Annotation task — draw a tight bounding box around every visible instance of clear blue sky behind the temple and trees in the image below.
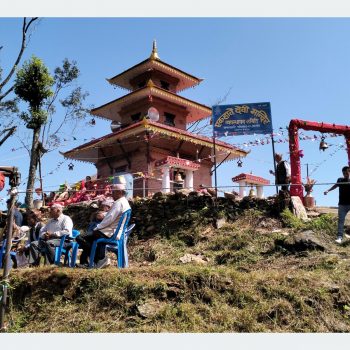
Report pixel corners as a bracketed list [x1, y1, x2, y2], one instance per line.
[0, 18, 350, 205]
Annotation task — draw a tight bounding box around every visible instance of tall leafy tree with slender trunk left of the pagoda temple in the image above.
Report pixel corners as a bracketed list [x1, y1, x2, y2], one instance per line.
[14, 57, 88, 207]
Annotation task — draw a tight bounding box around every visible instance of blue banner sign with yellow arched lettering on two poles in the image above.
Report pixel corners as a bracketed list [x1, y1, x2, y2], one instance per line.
[212, 102, 272, 137]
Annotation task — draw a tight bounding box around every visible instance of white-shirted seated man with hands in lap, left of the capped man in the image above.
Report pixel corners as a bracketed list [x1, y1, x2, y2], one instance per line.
[29, 203, 73, 266]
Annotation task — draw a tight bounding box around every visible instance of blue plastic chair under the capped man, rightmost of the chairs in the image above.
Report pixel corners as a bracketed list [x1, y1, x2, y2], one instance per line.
[89, 209, 131, 268]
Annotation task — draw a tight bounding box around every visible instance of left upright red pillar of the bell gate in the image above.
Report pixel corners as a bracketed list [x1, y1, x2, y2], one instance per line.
[289, 120, 303, 200]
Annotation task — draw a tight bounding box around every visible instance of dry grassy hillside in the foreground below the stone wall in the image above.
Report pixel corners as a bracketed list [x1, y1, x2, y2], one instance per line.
[4, 209, 350, 332]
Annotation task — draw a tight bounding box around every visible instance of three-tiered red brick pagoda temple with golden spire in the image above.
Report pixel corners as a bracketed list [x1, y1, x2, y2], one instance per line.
[62, 41, 247, 196]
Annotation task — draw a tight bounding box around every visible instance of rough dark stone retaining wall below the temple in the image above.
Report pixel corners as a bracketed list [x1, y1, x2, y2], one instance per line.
[65, 191, 281, 238]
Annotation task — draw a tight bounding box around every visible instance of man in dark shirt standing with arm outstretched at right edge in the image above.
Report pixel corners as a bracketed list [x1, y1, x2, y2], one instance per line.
[324, 166, 350, 244]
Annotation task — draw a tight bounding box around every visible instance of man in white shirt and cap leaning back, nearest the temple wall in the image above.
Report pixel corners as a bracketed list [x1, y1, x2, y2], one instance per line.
[76, 184, 130, 268]
